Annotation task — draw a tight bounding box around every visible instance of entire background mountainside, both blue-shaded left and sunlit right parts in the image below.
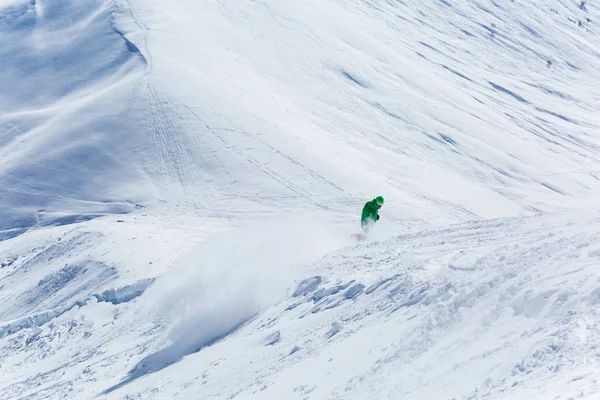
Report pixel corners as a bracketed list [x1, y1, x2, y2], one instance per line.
[0, 0, 600, 237]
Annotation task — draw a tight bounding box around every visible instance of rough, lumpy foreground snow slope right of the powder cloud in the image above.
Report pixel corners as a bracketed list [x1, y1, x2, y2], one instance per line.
[105, 211, 600, 399]
